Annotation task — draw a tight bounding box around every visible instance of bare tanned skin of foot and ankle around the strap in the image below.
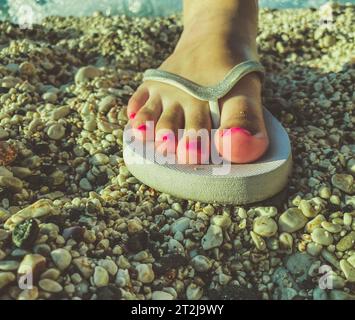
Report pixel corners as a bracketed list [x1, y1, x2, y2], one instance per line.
[127, 0, 269, 164]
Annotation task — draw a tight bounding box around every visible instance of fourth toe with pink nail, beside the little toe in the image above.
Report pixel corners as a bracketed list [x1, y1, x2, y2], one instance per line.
[131, 96, 162, 141]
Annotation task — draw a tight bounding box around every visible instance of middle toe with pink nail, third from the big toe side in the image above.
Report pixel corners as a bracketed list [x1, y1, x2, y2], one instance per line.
[155, 104, 184, 155]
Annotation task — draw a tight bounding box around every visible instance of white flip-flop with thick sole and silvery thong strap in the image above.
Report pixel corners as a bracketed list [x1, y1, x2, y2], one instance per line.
[123, 60, 292, 205]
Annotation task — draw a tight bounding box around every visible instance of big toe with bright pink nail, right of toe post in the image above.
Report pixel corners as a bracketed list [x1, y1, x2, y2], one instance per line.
[215, 95, 269, 163]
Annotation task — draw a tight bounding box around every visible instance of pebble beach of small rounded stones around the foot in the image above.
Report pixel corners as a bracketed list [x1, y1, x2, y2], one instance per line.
[0, 6, 355, 300]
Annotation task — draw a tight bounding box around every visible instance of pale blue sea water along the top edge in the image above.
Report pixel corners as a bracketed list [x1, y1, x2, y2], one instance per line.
[0, 0, 355, 22]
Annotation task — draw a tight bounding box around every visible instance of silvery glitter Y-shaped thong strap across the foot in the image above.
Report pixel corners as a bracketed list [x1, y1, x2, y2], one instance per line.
[143, 60, 265, 129]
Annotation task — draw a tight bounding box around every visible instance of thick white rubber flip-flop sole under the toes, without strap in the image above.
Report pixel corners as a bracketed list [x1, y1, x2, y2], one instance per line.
[123, 108, 292, 205]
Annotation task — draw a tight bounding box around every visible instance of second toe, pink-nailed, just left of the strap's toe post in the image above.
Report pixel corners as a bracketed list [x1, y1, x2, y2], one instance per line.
[177, 103, 211, 164]
